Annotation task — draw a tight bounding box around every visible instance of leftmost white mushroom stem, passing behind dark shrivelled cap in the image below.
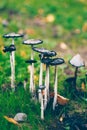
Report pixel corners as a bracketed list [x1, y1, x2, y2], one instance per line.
[10, 39, 15, 91]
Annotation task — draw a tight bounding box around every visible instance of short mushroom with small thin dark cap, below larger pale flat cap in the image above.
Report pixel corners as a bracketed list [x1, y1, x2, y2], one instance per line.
[25, 60, 37, 93]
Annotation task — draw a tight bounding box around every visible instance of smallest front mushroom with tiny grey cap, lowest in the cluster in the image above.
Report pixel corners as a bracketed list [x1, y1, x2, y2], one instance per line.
[38, 85, 45, 120]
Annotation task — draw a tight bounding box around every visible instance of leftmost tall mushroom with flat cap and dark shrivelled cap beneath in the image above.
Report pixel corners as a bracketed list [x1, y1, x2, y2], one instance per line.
[3, 32, 23, 91]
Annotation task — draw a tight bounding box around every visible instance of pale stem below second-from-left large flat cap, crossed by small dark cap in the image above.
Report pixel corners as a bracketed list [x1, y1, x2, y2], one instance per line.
[30, 50, 35, 93]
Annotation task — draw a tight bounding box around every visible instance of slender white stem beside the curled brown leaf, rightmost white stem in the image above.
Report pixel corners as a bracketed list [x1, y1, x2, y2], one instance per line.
[53, 65, 58, 110]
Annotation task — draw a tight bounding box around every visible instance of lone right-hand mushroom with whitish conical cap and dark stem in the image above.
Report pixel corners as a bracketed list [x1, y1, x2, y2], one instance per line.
[69, 54, 85, 90]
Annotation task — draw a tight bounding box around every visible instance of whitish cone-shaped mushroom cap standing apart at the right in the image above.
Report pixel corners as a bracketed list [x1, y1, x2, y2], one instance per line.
[70, 54, 85, 67]
